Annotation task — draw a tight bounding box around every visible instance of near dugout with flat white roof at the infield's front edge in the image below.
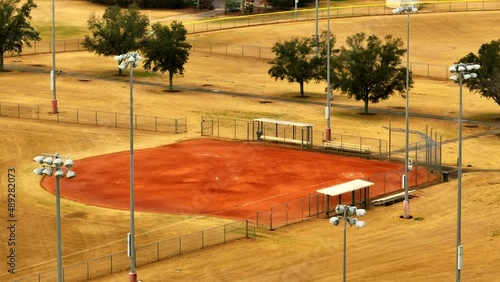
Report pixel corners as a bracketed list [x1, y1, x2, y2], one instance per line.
[316, 179, 375, 217]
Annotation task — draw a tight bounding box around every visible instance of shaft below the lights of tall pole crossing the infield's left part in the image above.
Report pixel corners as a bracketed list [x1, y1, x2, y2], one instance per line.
[128, 59, 137, 282]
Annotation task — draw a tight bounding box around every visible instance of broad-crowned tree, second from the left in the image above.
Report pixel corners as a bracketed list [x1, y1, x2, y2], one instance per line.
[82, 4, 149, 74]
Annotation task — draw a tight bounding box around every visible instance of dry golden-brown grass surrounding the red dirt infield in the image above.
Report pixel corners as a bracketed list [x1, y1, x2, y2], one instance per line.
[0, 1, 500, 282]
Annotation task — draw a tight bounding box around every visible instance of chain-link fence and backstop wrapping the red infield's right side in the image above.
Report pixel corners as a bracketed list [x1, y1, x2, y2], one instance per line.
[201, 117, 441, 230]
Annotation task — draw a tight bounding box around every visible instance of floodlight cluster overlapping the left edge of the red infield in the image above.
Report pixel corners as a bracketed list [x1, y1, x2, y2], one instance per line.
[33, 153, 76, 179]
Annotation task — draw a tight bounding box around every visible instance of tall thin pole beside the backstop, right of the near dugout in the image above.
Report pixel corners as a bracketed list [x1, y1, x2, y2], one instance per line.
[403, 9, 411, 219]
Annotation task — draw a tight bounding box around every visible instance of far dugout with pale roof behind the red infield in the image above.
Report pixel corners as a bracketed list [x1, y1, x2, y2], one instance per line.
[253, 118, 313, 147]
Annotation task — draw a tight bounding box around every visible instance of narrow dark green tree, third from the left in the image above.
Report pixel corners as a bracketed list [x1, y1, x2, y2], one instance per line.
[142, 21, 191, 91]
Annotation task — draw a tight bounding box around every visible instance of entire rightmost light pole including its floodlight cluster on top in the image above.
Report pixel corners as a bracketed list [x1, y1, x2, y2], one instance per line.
[449, 63, 481, 282]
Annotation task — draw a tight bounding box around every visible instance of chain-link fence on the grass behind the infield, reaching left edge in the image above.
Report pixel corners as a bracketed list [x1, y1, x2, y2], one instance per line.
[0, 102, 187, 134]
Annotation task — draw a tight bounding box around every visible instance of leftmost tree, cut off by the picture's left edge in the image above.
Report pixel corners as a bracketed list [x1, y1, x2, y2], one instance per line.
[0, 0, 41, 71]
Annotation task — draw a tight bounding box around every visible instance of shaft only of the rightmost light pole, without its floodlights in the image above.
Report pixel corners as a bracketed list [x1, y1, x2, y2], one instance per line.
[456, 72, 463, 282]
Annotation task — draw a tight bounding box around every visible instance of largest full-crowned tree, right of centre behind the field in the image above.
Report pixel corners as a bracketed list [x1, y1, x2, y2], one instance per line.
[331, 33, 413, 114]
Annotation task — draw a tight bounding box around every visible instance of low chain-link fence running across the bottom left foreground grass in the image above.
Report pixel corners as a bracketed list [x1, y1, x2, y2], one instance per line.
[14, 220, 256, 282]
